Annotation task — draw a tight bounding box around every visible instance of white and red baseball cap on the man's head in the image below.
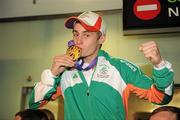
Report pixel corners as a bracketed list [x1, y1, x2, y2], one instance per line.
[65, 11, 106, 35]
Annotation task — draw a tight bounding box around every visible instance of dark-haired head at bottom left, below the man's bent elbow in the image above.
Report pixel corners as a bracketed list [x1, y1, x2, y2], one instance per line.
[14, 109, 48, 120]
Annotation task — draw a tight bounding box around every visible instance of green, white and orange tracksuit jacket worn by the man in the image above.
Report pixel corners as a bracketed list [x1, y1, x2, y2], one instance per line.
[29, 50, 174, 120]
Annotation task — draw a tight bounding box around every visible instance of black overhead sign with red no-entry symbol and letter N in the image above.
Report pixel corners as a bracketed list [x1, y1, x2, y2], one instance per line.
[123, 0, 180, 35]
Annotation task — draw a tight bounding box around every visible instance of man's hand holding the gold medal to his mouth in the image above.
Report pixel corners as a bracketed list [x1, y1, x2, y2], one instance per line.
[51, 54, 74, 76]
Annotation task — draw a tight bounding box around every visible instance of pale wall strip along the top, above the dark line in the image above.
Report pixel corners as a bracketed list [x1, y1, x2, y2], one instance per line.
[0, 0, 122, 18]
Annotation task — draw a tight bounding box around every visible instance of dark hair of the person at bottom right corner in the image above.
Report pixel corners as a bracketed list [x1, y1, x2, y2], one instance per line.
[150, 106, 180, 120]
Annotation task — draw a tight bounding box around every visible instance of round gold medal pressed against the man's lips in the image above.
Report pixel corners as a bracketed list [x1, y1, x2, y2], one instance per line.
[66, 45, 81, 61]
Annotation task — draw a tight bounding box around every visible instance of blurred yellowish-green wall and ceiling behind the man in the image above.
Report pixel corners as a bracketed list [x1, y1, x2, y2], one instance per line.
[0, 0, 180, 120]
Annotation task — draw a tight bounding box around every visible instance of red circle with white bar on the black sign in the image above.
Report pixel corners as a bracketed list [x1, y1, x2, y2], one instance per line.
[133, 0, 161, 20]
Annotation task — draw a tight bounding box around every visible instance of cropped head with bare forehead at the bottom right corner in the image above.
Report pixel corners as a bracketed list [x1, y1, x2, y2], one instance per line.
[149, 106, 180, 120]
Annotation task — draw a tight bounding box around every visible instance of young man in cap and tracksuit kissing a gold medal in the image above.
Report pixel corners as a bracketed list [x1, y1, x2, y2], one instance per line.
[30, 12, 173, 120]
